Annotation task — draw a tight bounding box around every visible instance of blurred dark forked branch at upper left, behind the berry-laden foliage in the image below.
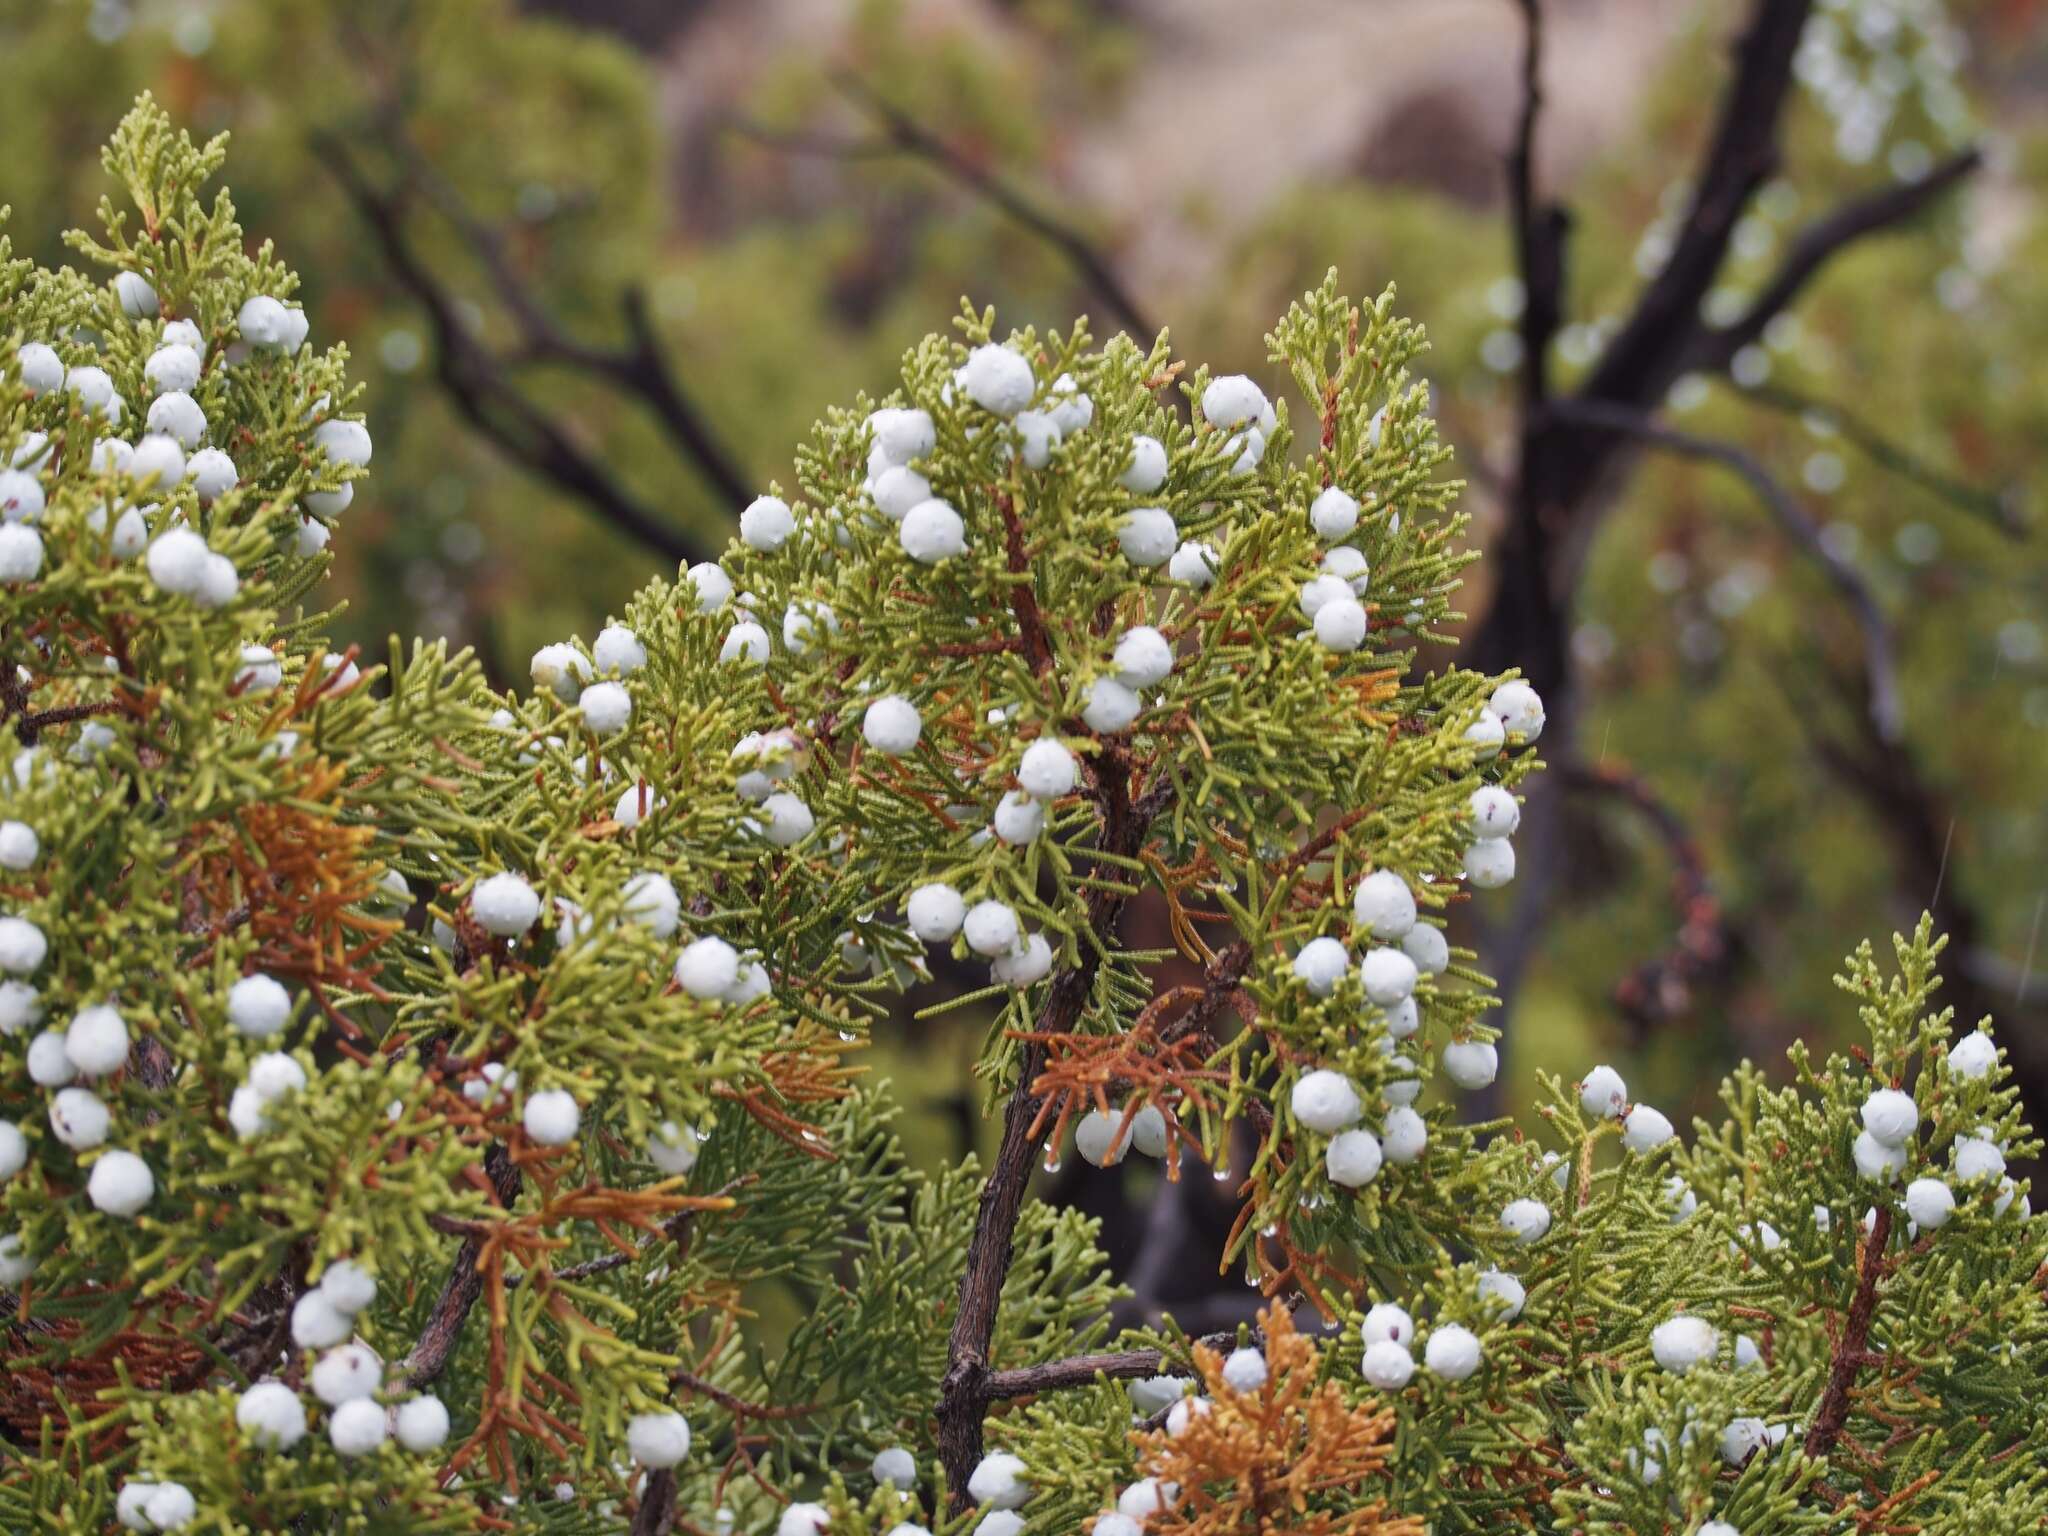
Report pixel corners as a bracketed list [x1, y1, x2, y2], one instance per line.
[319, 135, 748, 561]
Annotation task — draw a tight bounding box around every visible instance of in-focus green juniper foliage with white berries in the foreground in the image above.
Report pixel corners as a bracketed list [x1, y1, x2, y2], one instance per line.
[0, 102, 2048, 1536]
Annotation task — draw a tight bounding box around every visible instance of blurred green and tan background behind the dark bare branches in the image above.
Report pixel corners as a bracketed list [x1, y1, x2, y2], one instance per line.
[0, 0, 2048, 1204]
